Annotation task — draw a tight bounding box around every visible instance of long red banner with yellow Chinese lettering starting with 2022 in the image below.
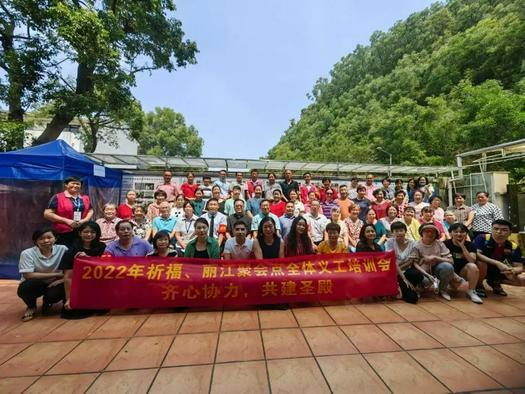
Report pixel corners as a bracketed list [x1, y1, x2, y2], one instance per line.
[71, 252, 397, 309]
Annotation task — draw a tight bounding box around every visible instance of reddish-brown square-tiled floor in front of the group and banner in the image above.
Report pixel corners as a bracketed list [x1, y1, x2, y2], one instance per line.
[0, 281, 525, 394]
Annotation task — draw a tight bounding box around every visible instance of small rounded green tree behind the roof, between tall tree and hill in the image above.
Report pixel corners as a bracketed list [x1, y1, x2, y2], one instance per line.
[131, 107, 203, 157]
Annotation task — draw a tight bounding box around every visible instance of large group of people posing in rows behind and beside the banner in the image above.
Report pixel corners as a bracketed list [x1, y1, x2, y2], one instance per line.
[18, 169, 525, 320]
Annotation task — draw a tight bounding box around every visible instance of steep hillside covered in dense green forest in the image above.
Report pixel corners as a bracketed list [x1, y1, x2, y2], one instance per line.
[268, 0, 525, 165]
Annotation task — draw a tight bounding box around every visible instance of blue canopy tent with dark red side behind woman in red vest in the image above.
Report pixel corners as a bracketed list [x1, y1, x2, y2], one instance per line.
[0, 140, 122, 278]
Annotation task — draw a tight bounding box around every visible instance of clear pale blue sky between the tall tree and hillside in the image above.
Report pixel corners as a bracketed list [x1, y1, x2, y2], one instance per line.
[134, 0, 434, 159]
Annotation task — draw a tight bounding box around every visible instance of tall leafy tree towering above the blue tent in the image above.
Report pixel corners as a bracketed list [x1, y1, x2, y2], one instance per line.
[0, 0, 197, 143]
